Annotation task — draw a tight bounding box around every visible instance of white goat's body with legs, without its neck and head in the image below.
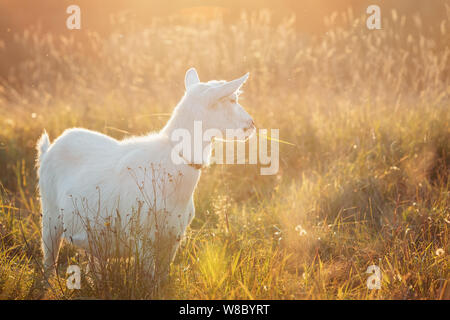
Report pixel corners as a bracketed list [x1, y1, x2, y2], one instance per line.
[39, 129, 200, 268]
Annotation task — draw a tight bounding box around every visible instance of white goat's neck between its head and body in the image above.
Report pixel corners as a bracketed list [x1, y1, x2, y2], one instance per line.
[161, 106, 212, 165]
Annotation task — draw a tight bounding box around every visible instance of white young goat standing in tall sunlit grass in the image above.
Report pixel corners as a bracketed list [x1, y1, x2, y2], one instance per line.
[37, 68, 255, 273]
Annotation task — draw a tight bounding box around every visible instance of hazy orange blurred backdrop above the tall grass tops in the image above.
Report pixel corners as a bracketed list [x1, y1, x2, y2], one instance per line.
[0, 0, 448, 35]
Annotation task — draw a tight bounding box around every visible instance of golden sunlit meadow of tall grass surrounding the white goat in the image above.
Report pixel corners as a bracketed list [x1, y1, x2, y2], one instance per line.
[0, 7, 450, 299]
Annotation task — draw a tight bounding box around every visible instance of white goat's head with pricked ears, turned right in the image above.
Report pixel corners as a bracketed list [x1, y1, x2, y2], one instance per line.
[183, 68, 255, 139]
